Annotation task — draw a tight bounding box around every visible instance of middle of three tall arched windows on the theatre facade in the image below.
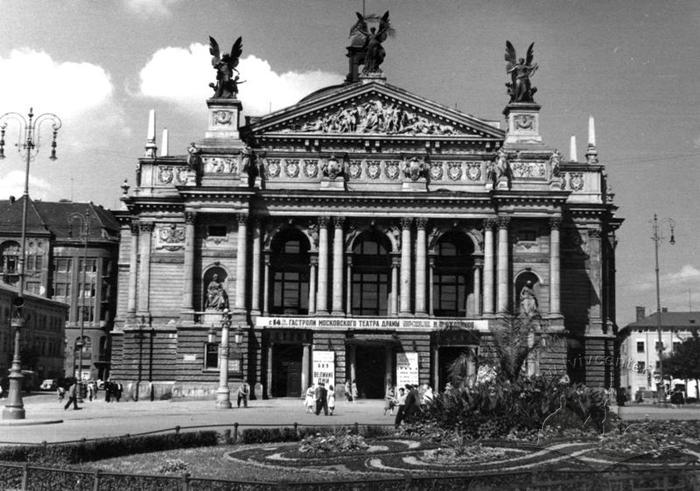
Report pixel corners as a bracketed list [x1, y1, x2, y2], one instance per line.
[351, 231, 391, 316]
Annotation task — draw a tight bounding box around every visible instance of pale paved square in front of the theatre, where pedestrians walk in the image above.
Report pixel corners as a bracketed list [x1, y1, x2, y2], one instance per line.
[0, 394, 700, 444]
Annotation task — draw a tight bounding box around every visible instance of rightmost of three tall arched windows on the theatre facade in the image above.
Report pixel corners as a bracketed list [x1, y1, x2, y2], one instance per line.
[433, 232, 474, 317]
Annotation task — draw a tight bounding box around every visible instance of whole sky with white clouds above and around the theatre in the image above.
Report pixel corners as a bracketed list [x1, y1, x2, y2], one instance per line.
[0, 0, 700, 326]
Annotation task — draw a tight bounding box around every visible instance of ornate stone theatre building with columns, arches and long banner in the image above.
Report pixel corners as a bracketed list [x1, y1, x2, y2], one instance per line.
[112, 21, 621, 397]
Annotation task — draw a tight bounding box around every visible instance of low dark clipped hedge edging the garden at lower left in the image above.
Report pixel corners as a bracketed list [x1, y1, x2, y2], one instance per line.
[0, 431, 218, 465]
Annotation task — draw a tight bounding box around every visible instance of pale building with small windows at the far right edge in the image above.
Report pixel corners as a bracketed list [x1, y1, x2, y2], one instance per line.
[619, 307, 700, 399]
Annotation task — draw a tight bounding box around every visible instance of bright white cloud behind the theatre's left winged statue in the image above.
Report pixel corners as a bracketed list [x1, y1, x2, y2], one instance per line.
[139, 43, 343, 115]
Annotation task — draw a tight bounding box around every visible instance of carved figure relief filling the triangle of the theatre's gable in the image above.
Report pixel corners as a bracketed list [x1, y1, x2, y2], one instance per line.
[300, 100, 458, 135]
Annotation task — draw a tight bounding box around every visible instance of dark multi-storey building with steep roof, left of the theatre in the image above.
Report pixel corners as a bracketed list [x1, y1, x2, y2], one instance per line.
[0, 199, 119, 379]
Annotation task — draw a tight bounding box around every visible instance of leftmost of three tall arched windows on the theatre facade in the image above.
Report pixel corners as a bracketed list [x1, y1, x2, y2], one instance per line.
[270, 229, 309, 315]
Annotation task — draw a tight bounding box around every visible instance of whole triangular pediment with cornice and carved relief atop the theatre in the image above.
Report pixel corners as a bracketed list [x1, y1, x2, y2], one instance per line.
[248, 82, 504, 140]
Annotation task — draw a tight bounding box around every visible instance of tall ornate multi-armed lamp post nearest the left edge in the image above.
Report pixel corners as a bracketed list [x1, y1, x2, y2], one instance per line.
[0, 108, 61, 419]
